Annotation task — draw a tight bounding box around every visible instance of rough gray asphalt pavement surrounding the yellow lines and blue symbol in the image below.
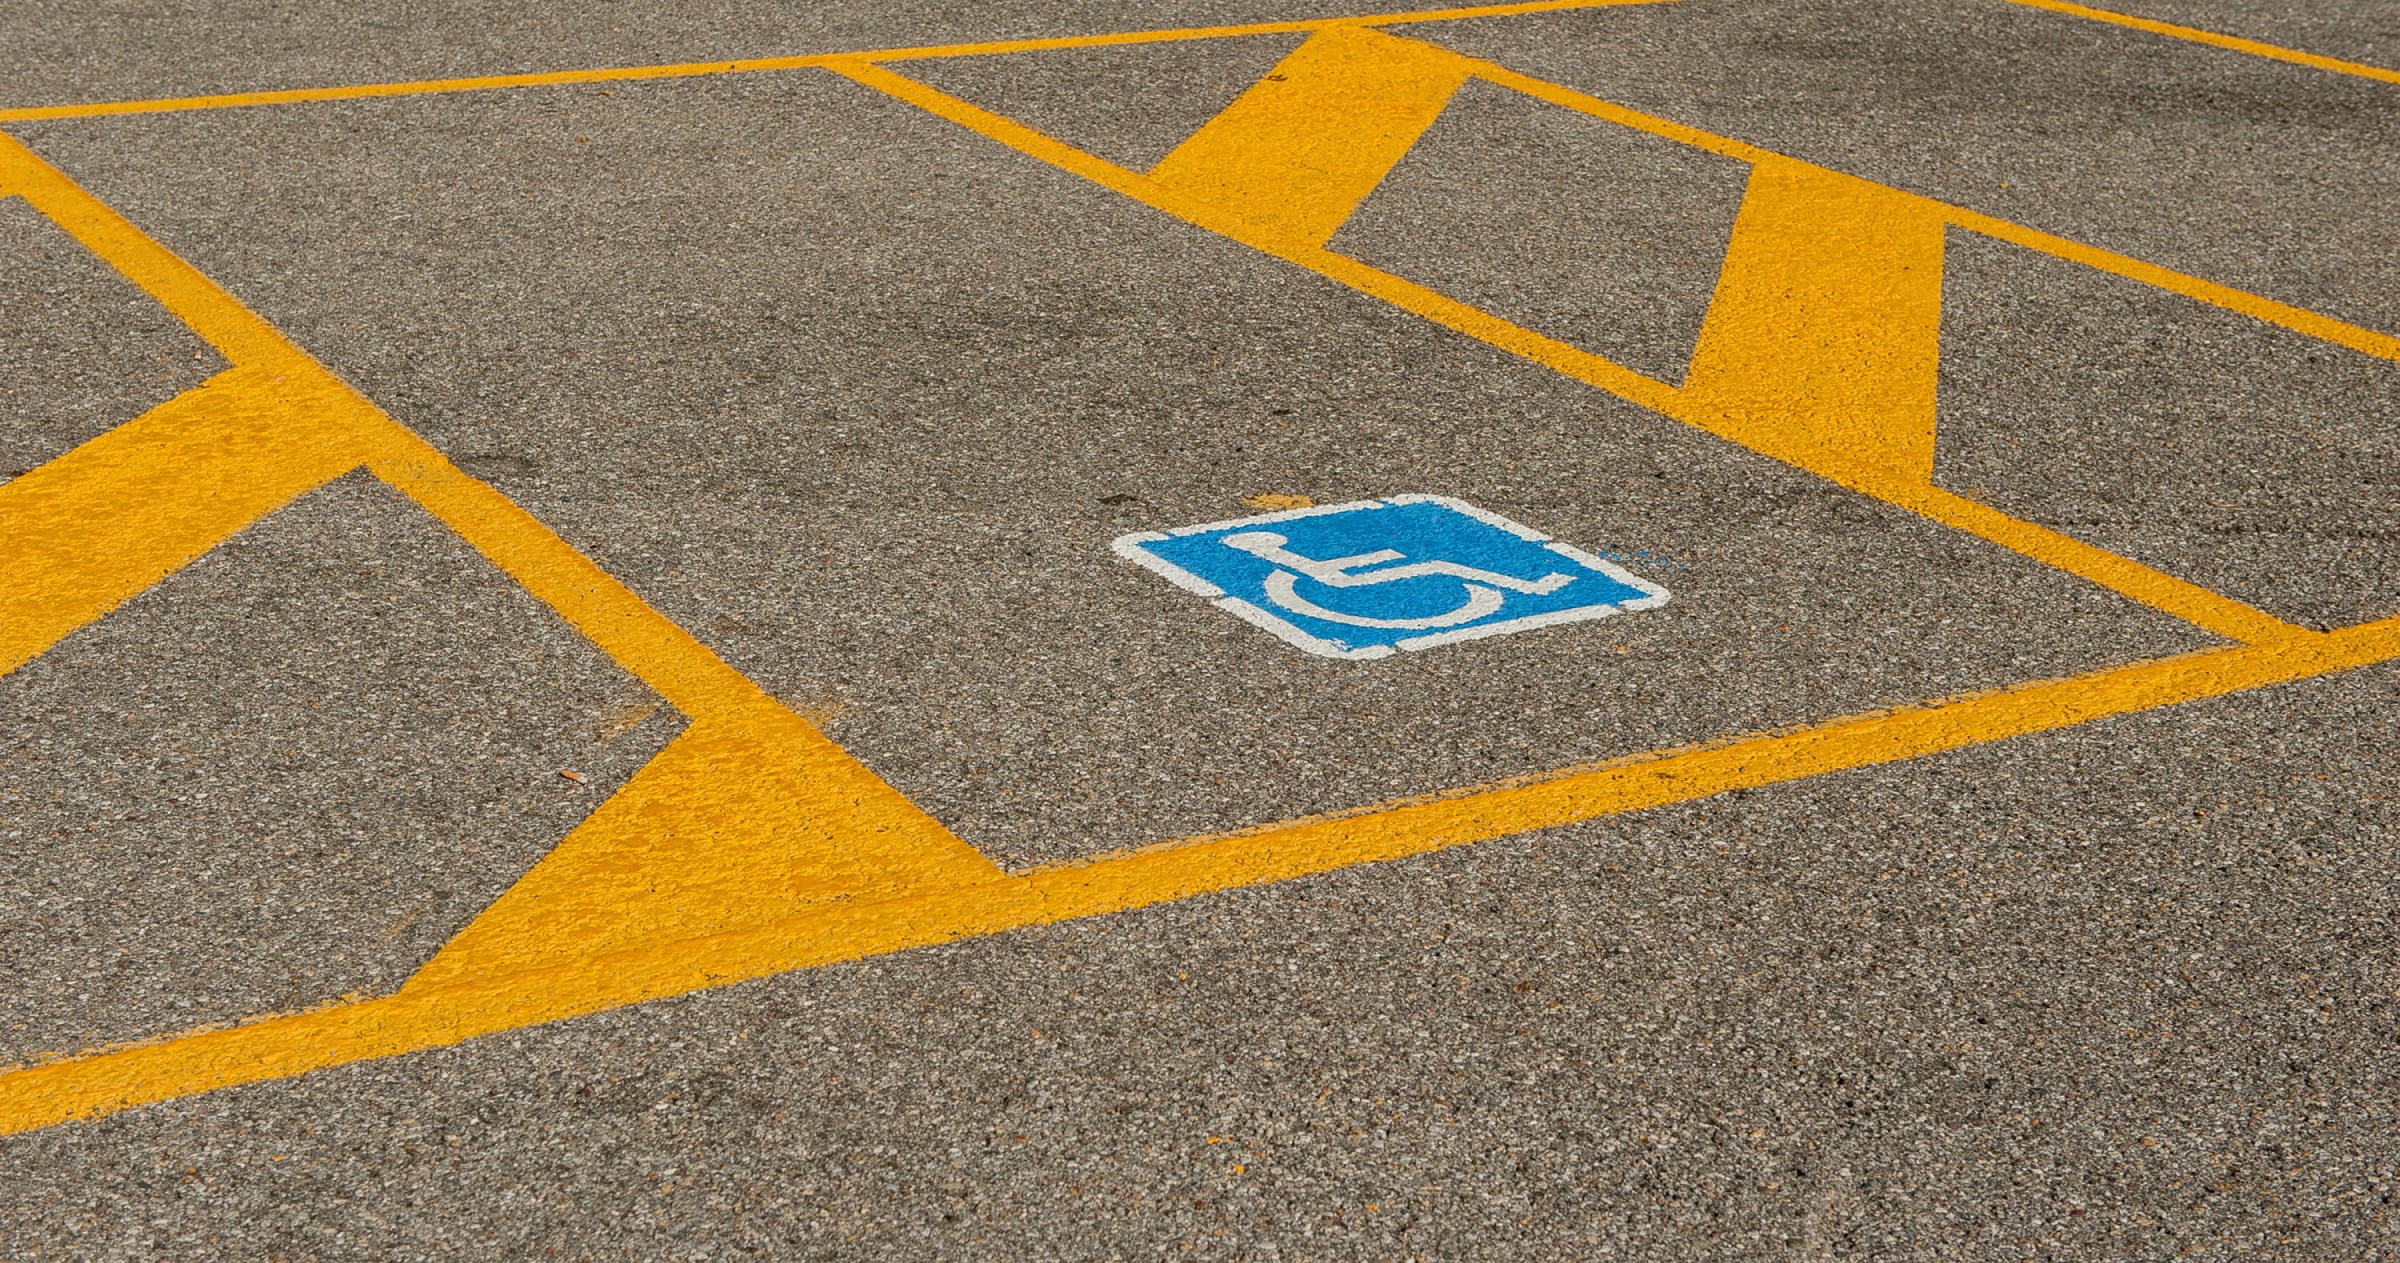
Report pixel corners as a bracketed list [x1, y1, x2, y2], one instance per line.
[0, 0, 2400, 1261]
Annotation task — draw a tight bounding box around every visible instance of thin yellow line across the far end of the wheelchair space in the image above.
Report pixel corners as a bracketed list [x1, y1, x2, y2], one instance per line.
[0, 0, 1675, 122]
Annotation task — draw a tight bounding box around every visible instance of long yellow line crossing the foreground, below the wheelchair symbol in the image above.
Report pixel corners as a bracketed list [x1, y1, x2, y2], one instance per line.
[0, 619, 2400, 1133]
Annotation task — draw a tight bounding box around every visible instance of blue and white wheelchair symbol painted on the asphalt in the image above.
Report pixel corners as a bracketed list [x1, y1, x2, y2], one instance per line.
[1116, 495, 1668, 658]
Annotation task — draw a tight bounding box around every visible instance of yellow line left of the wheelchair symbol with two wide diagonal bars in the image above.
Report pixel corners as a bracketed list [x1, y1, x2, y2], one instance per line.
[0, 137, 1003, 1131]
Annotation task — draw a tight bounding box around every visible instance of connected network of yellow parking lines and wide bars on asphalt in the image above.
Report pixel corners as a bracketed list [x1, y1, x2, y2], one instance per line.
[0, 0, 2400, 1131]
